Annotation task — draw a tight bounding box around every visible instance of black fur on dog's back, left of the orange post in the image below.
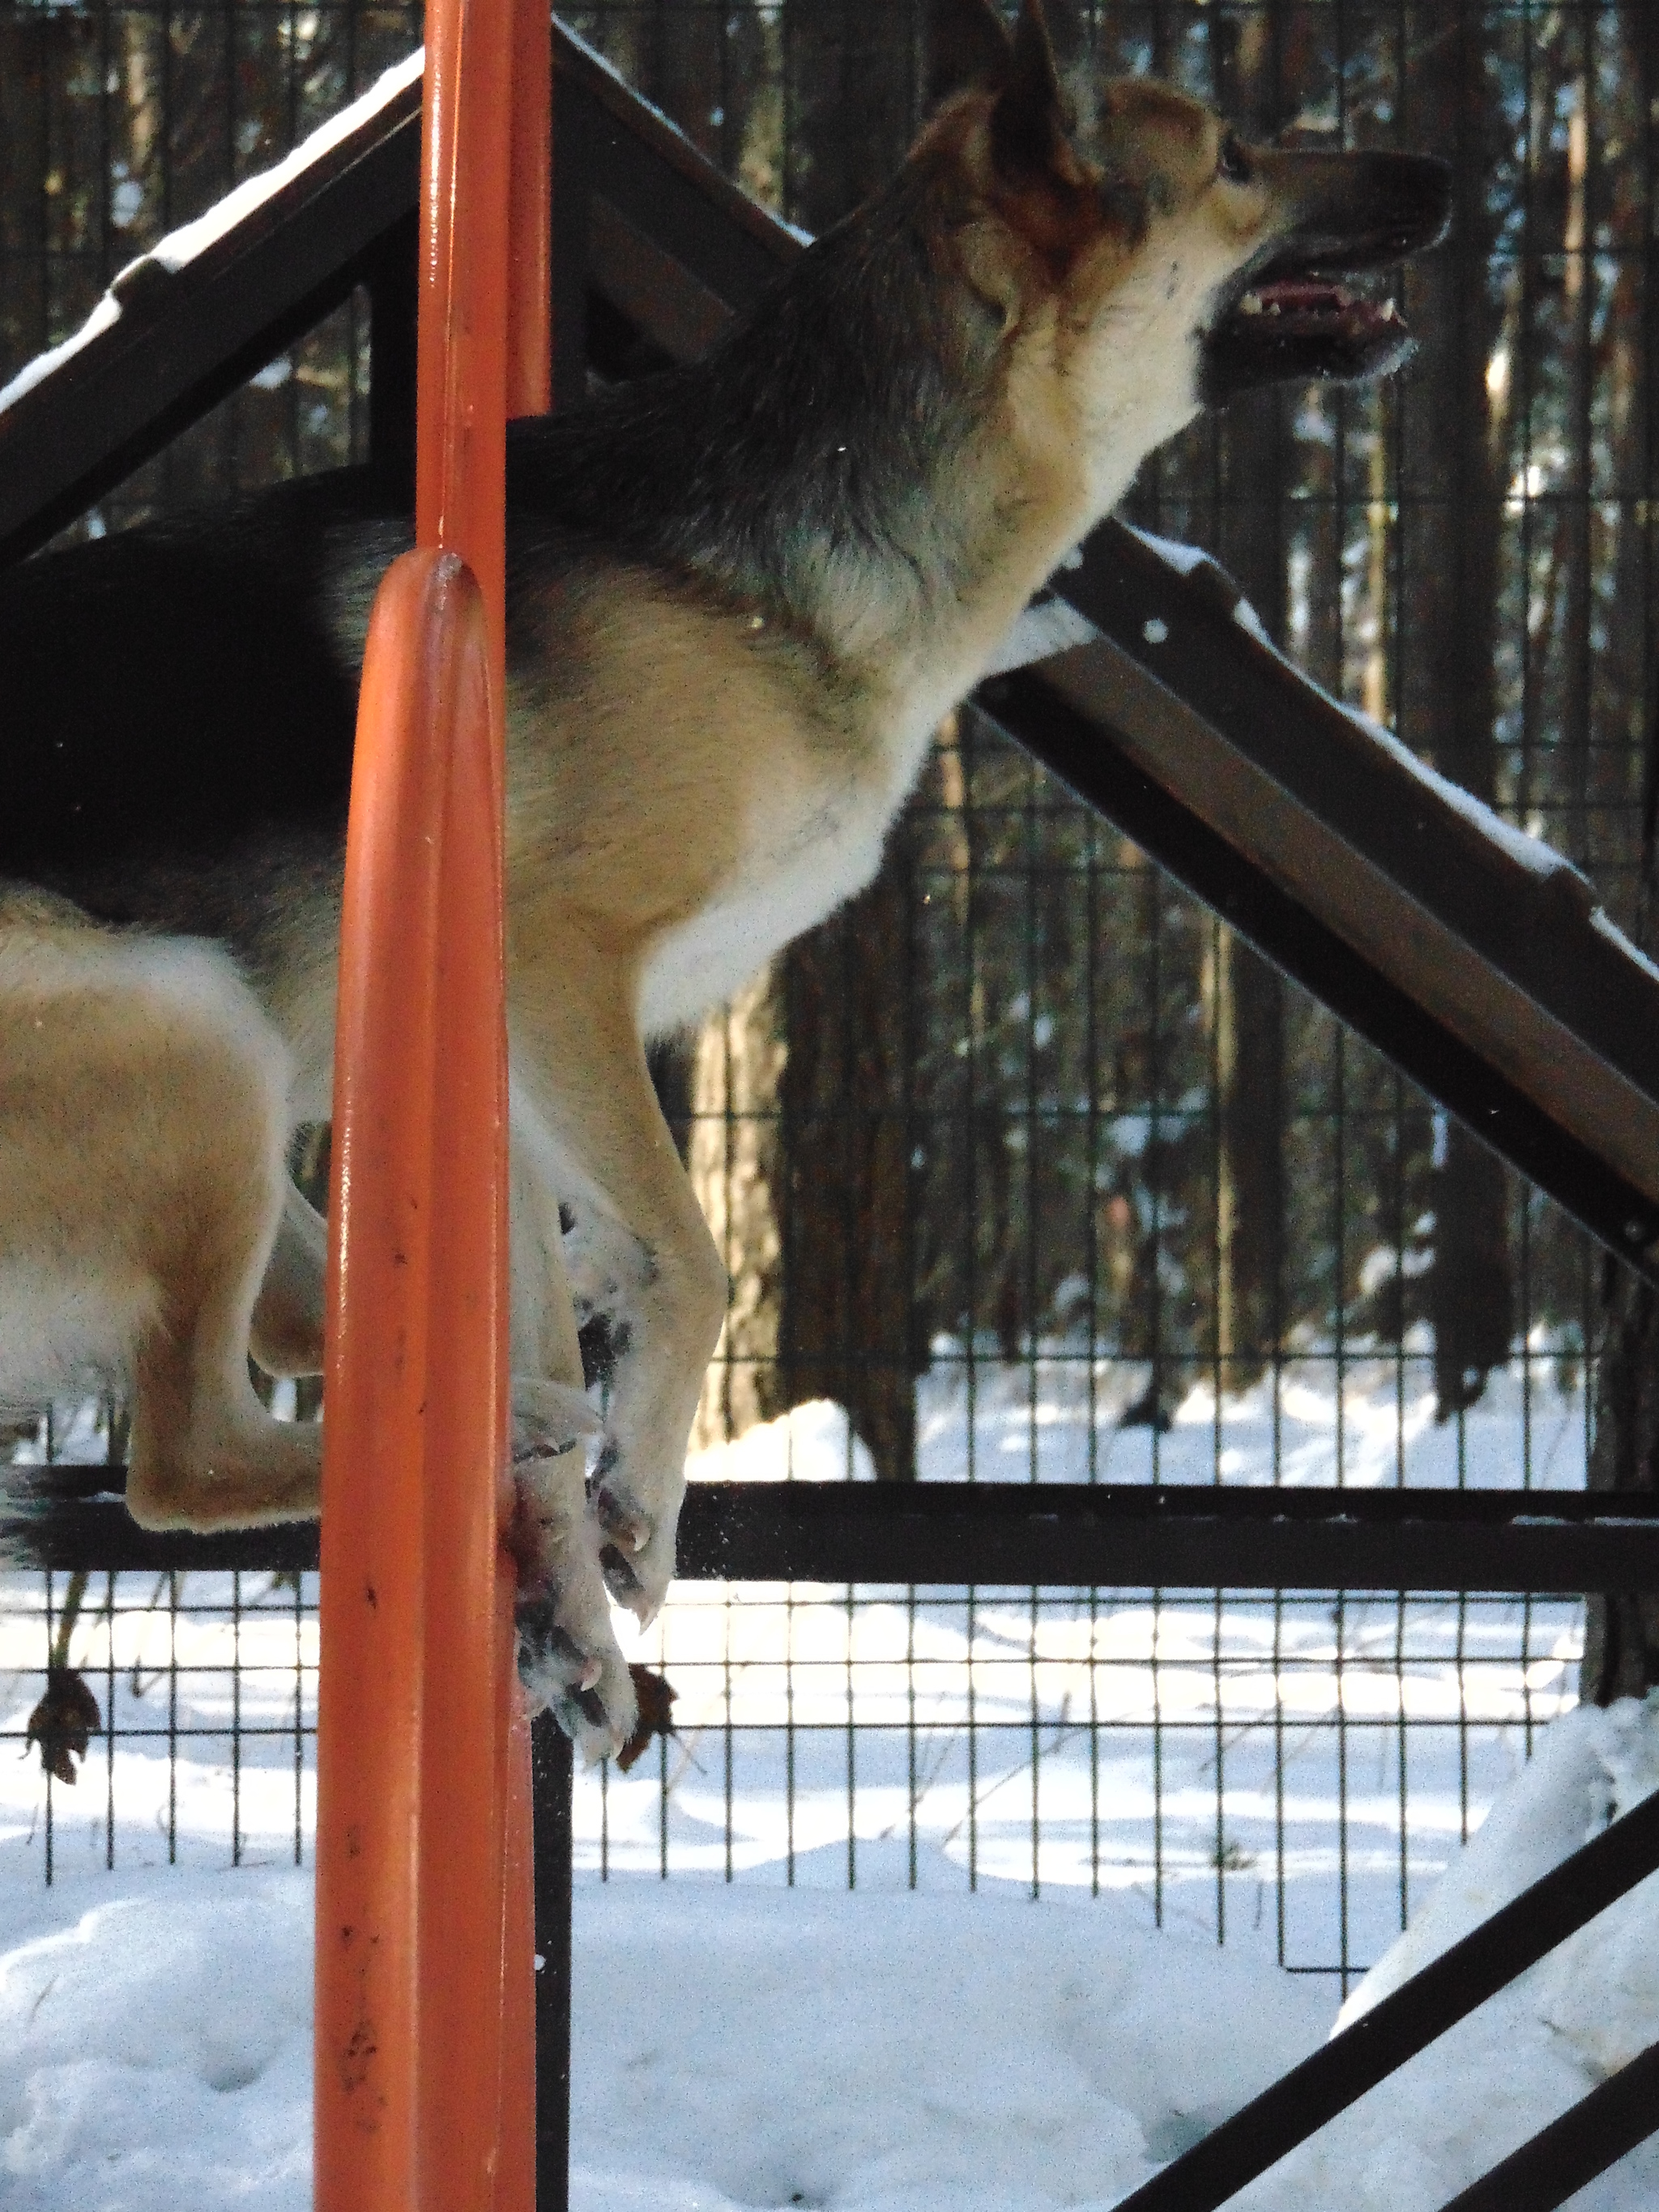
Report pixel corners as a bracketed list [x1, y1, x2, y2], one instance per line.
[0, 471, 400, 887]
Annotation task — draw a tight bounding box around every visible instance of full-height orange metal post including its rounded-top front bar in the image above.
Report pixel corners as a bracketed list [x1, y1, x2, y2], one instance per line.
[314, 0, 551, 2212]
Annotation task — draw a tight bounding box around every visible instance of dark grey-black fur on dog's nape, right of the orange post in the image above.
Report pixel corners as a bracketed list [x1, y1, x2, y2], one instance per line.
[509, 166, 1000, 619]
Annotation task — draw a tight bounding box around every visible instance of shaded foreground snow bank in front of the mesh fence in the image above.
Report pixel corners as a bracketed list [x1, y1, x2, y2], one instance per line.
[0, 1706, 1659, 2212]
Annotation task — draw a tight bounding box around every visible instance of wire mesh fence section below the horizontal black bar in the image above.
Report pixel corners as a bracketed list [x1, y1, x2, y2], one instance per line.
[0, 1575, 1581, 1988]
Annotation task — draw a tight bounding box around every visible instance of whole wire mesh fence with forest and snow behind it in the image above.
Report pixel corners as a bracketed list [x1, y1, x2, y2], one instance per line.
[0, 0, 1659, 2008]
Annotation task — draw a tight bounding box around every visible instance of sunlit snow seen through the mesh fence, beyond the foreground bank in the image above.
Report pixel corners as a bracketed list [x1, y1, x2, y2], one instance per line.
[0, 1352, 1584, 1978]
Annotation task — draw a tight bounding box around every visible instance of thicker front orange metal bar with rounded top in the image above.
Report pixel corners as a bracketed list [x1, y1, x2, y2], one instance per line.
[316, 549, 506, 2212]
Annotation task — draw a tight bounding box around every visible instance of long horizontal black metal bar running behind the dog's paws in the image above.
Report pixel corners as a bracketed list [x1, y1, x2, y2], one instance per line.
[0, 1467, 1659, 1597]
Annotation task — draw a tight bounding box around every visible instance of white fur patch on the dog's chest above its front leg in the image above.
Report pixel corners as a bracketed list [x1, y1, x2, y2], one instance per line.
[639, 728, 927, 1036]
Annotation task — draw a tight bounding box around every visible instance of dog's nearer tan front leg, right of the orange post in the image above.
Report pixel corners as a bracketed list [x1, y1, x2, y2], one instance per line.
[509, 918, 726, 1621]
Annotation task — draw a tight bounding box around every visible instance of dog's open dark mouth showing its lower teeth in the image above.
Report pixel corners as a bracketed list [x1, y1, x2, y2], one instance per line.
[1203, 270, 1414, 405]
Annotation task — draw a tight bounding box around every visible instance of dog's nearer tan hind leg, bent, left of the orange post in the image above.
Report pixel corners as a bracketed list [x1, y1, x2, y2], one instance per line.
[0, 916, 321, 1528]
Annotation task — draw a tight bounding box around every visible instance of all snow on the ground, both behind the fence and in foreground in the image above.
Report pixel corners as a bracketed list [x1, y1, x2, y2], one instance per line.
[0, 1349, 1627, 2212]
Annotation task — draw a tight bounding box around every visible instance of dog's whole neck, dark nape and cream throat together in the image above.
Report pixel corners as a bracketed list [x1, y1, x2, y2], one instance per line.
[511, 170, 1190, 728]
